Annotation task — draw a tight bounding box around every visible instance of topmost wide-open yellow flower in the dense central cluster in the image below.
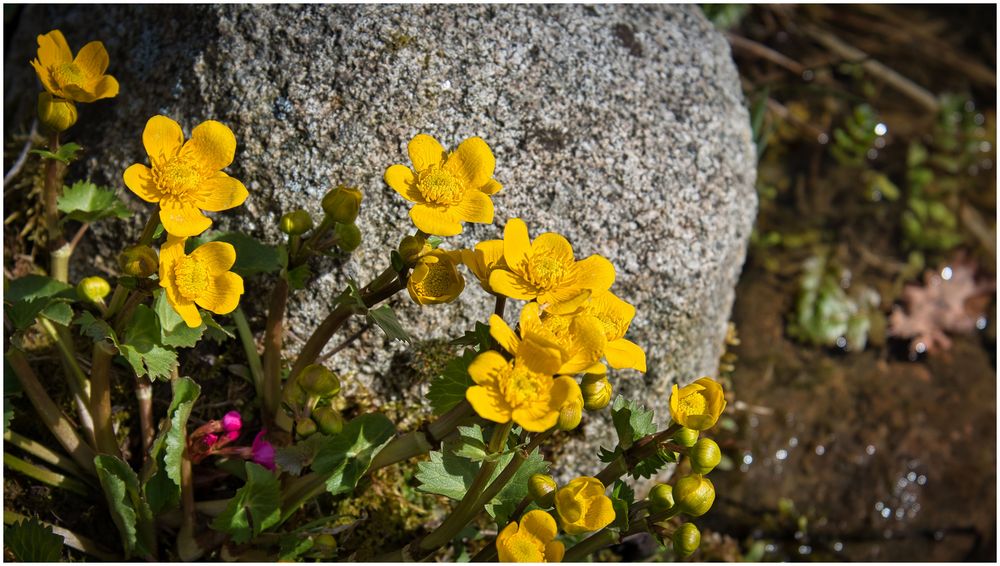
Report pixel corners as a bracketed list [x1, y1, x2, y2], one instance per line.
[490, 218, 615, 312]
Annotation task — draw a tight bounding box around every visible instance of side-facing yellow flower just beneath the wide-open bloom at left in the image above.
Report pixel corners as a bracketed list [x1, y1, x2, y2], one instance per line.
[160, 235, 243, 328]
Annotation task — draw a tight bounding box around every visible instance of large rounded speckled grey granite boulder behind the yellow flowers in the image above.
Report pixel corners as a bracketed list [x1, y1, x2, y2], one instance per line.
[5, 5, 757, 480]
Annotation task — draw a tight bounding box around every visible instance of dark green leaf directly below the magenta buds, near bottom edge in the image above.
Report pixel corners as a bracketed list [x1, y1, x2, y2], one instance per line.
[212, 462, 281, 544]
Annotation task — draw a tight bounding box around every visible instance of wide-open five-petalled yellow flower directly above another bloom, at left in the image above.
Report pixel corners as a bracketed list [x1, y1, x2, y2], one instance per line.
[124, 116, 247, 237]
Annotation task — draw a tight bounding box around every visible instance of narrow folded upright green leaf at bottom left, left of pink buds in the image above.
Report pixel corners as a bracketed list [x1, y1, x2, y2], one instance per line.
[94, 454, 155, 558]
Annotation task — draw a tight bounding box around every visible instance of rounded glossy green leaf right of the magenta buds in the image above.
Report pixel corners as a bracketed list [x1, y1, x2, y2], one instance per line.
[312, 413, 396, 495]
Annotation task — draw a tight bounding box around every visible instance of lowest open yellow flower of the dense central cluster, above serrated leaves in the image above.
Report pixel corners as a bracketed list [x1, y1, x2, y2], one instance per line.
[465, 351, 580, 432]
